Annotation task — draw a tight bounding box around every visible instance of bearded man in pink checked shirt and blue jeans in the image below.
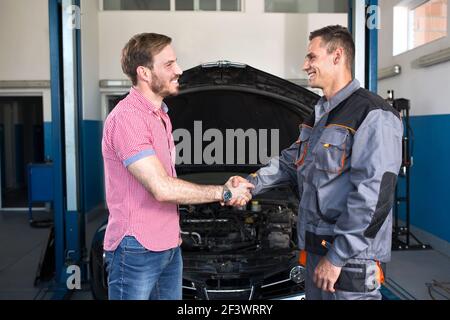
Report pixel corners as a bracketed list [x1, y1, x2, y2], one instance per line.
[102, 33, 253, 300]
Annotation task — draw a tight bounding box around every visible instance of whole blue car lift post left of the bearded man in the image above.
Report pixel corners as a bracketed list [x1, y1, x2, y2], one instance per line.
[48, 0, 87, 299]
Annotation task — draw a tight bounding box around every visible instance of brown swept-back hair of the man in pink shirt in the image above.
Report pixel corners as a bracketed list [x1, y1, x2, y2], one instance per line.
[121, 33, 172, 85]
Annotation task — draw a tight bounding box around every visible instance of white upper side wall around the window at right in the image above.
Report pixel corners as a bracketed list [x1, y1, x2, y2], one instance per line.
[378, 0, 450, 115]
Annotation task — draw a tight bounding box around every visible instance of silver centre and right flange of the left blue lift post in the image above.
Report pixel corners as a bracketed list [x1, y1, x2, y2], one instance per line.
[62, 0, 87, 286]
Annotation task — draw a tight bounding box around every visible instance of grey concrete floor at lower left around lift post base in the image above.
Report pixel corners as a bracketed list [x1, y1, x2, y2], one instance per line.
[0, 209, 107, 300]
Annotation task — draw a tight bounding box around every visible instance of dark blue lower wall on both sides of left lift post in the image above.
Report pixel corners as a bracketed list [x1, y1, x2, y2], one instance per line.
[44, 120, 105, 213]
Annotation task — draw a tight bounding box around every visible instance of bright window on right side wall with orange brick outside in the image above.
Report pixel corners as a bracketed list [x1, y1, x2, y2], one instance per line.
[393, 0, 448, 55]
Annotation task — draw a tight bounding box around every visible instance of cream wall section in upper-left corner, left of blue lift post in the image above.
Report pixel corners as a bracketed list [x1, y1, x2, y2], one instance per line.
[0, 0, 50, 80]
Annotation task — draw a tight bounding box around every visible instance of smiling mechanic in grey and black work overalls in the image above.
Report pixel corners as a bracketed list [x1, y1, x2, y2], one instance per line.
[233, 26, 403, 300]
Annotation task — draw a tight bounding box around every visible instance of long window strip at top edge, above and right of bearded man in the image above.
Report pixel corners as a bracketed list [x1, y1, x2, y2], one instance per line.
[103, 0, 242, 11]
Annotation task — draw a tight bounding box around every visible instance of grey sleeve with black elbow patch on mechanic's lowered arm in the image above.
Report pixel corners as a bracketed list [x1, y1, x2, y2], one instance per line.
[327, 109, 403, 266]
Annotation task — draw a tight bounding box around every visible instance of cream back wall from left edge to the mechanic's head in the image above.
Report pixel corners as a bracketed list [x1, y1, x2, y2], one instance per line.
[0, 0, 347, 121]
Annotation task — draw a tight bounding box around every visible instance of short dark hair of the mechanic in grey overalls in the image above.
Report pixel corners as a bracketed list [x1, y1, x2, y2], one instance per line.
[309, 25, 355, 70]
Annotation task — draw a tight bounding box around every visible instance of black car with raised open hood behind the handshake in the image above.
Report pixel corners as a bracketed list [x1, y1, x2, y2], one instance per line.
[90, 61, 319, 300]
